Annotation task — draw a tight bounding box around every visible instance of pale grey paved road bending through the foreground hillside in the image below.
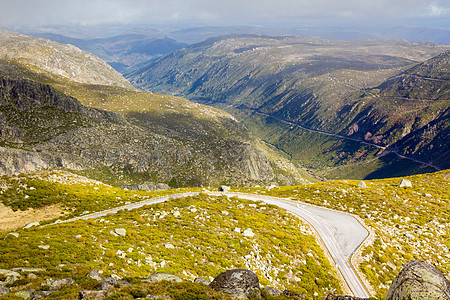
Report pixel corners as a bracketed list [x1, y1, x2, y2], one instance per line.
[54, 192, 370, 298]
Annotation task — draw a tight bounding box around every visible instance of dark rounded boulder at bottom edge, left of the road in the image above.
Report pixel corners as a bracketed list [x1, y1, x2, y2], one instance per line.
[209, 269, 261, 299]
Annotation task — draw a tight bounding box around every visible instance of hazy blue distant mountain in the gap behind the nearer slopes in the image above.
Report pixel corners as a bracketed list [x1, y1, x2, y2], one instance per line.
[32, 33, 188, 71]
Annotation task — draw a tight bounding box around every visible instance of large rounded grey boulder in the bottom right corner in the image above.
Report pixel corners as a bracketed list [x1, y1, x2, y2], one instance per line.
[386, 260, 450, 300]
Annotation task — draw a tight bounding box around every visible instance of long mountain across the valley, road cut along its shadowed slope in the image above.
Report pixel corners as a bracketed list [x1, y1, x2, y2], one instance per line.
[125, 35, 449, 178]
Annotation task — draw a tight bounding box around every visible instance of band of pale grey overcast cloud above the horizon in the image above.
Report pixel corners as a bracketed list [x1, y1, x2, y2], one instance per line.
[0, 0, 450, 27]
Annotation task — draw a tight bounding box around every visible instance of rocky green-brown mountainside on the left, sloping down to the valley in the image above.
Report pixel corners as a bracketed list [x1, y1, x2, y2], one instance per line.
[0, 32, 301, 187]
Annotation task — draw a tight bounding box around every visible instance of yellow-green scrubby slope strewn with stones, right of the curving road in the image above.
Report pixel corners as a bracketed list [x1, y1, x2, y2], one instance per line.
[237, 171, 450, 299]
